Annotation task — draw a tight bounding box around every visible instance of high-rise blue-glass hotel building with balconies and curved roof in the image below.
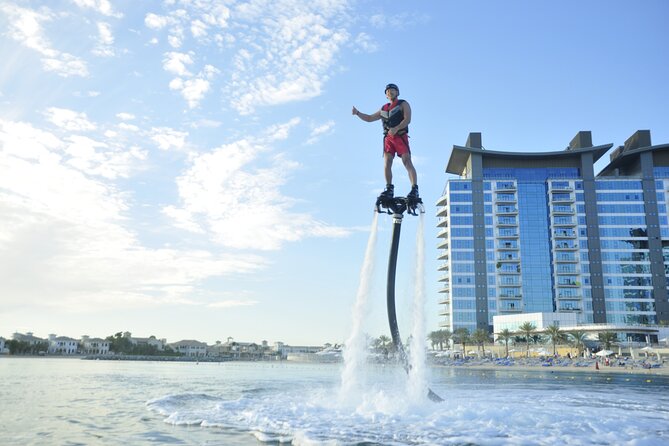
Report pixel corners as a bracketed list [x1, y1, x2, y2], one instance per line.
[437, 131, 669, 338]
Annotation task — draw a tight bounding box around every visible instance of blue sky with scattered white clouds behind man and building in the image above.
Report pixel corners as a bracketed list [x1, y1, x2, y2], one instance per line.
[0, 0, 669, 345]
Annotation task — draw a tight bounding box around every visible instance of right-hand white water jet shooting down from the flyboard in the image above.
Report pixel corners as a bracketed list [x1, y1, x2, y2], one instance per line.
[407, 214, 428, 403]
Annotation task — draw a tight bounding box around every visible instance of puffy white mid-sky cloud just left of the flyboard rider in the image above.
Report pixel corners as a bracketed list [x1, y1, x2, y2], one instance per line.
[164, 121, 347, 250]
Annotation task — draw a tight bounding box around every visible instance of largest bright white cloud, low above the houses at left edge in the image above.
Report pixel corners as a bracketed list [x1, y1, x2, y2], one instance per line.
[0, 119, 266, 311]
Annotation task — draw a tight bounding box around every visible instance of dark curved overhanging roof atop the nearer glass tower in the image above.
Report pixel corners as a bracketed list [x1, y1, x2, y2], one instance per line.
[446, 144, 613, 175]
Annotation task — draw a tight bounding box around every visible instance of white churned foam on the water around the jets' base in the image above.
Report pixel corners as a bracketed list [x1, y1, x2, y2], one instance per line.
[147, 368, 669, 446]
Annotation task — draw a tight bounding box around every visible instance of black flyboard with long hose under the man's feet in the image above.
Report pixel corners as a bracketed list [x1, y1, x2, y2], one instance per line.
[376, 196, 444, 402]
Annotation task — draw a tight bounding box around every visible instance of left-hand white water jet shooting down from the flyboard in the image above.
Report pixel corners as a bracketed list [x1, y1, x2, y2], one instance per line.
[339, 212, 379, 401]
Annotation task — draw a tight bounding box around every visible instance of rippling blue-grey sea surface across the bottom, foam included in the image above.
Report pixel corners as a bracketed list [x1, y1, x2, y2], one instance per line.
[0, 357, 669, 446]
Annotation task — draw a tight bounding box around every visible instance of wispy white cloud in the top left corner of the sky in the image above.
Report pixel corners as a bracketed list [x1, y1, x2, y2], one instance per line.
[0, 4, 88, 77]
